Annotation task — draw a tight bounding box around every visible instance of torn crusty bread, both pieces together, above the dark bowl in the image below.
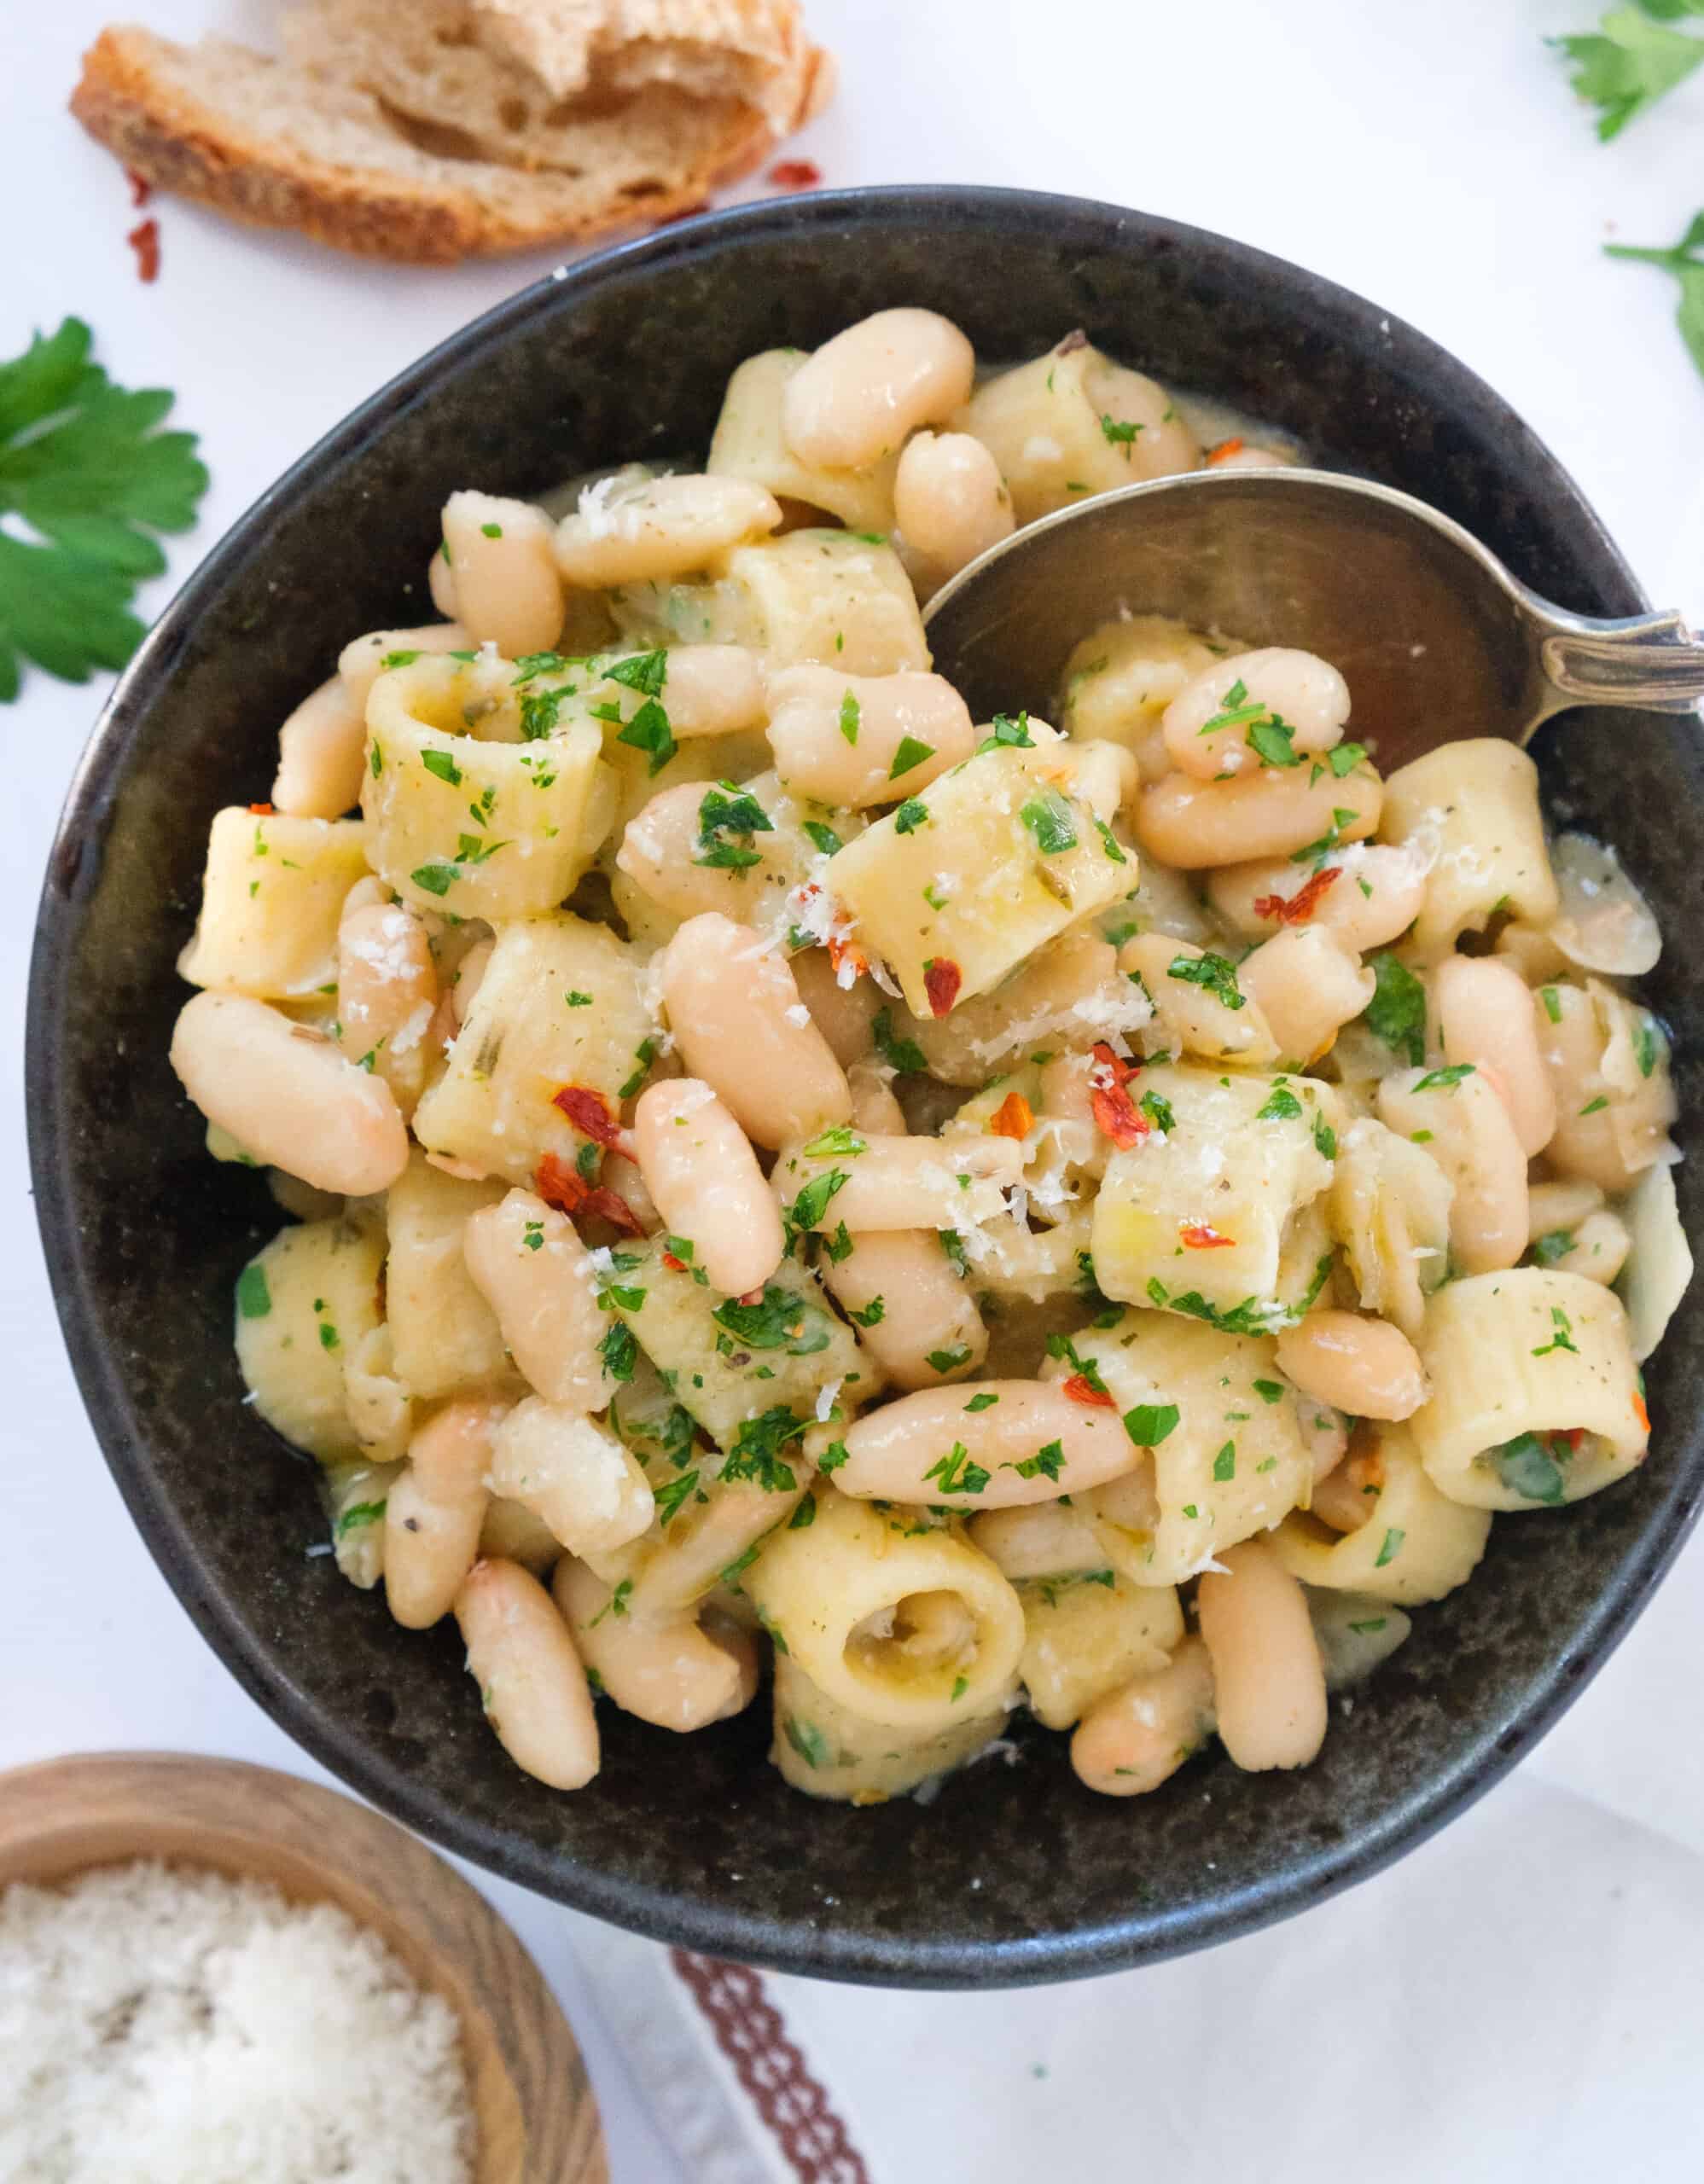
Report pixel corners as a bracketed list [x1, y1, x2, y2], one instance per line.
[72, 0, 832, 264]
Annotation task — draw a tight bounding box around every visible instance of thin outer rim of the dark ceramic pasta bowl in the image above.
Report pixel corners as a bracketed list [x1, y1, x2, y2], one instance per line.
[24, 183, 1697, 1988]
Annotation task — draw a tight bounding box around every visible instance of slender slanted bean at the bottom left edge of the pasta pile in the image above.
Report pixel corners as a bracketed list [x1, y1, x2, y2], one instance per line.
[457, 1561, 599, 1789]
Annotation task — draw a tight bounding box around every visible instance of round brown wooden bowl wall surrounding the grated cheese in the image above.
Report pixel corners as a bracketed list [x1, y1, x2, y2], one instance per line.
[0, 1751, 609, 2184]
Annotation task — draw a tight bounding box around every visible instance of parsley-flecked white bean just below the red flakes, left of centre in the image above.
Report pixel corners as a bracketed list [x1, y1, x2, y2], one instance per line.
[461, 1190, 609, 1411]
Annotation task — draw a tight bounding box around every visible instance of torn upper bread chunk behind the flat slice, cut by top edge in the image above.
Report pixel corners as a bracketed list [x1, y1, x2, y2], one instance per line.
[282, 0, 811, 175]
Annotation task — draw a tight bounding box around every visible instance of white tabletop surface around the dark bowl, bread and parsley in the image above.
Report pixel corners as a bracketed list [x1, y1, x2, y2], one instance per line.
[0, 0, 1704, 2184]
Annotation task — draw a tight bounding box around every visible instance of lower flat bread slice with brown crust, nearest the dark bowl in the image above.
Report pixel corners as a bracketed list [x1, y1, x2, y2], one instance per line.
[72, 0, 826, 264]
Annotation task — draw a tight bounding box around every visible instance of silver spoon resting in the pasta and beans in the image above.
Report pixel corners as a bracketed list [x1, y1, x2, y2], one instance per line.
[924, 469, 1704, 773]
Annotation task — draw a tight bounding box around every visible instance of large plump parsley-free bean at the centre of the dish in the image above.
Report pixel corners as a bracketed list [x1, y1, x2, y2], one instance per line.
[662, 913, 852, 1149]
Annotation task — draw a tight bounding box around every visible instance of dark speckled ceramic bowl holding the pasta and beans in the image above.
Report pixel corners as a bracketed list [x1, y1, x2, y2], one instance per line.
[28, 190, 1704, 1985]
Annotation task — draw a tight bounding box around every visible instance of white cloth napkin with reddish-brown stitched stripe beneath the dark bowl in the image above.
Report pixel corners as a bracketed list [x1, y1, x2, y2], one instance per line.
[574, 1774, 1704, 2184]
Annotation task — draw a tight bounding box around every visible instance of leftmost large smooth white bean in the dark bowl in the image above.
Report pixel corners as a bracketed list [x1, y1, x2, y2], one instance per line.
[171, 994, 409, 1199]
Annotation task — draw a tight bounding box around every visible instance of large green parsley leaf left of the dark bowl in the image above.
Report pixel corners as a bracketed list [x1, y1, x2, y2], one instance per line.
[0, 319, 207, 703]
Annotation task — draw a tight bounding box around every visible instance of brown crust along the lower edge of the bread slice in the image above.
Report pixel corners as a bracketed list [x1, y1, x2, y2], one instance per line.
[70, 28, 829, 264]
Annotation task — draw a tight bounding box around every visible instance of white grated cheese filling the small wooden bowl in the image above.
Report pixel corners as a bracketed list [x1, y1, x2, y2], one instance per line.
[0, 1863, 474, 2184]
